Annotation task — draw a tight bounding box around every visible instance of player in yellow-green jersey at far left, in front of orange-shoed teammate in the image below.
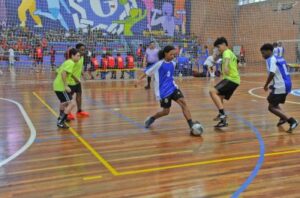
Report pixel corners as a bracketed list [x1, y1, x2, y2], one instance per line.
[53, 48, 80, 129]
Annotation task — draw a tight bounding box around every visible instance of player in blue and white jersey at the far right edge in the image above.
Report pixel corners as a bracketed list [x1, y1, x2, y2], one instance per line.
[260, 43, 298, 133]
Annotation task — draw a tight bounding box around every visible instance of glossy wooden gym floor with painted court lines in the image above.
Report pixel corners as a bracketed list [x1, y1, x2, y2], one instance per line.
[0, 72, 300, 198]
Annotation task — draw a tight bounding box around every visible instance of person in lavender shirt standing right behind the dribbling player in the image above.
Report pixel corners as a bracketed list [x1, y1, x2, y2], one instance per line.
[143, 41, 159, 89]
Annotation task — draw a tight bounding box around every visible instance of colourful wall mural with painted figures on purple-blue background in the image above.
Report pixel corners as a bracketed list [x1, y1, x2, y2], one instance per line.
[4, 0, 190, 36]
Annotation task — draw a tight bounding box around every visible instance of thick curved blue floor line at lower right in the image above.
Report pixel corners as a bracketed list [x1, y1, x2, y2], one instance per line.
[228, 113, 265, 198]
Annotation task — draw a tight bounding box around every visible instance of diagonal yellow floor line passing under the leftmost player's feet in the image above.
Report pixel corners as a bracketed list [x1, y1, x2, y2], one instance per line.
[33, 92, 119, 175]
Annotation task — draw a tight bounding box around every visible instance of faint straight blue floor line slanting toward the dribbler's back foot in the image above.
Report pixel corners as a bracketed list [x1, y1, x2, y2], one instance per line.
[86, 96, 149, 132]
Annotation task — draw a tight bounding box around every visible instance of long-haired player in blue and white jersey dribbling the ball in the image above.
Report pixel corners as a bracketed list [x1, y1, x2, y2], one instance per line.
[135, 46, 198, 134]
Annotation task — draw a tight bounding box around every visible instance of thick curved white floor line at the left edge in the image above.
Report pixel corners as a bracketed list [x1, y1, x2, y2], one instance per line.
[0, 98, 36, 167]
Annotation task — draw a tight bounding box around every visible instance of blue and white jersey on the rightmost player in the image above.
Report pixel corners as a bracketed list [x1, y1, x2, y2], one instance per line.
[267, 56, 292, 94]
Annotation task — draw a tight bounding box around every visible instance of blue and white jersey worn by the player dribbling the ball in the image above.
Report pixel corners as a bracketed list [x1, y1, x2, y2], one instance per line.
[145, 60, 178, 100]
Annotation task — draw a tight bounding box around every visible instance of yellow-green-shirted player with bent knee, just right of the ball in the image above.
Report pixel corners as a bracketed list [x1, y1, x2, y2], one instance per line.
[209, 37, 240, 128]
